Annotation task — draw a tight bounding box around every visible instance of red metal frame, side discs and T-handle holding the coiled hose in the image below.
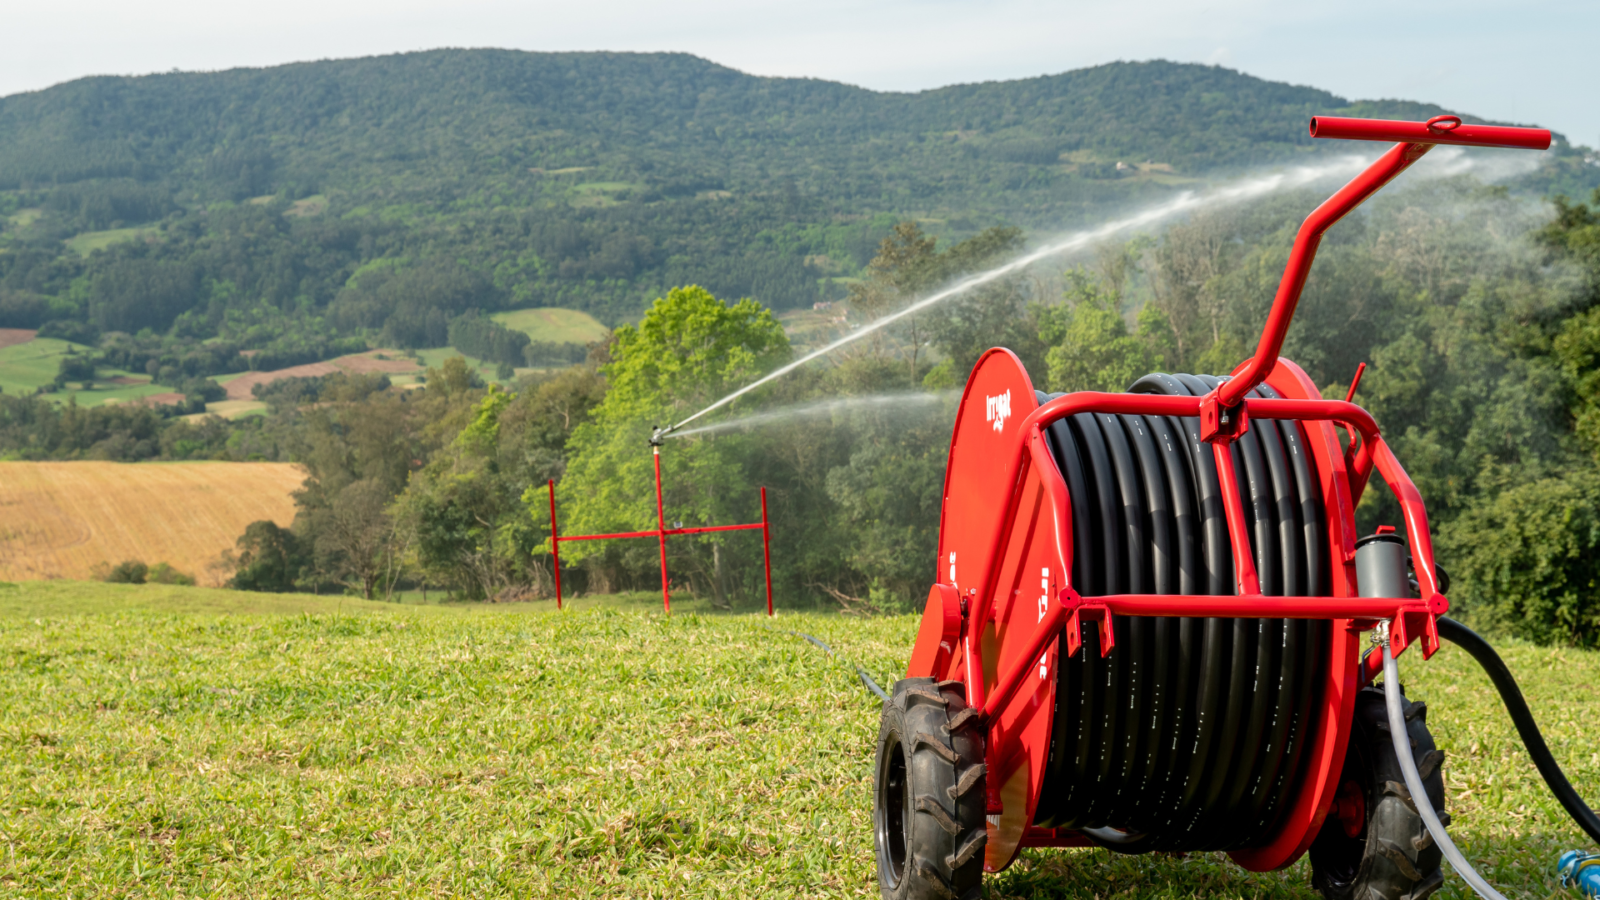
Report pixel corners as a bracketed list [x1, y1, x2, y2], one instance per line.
[907, 117, 1550, 871]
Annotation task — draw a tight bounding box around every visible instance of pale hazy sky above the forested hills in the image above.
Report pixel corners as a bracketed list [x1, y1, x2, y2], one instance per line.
[0, 0, 1600, 146]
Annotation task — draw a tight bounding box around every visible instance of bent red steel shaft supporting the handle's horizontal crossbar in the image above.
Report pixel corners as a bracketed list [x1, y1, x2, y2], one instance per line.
[1211, 143, 1430, 407]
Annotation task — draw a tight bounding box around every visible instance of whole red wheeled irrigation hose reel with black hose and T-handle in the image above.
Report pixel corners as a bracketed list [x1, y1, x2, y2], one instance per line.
[874, 117, 1600, 900]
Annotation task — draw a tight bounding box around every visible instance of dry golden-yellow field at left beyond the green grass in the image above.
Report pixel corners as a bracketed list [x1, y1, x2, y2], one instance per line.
[0, 463, 306, 585]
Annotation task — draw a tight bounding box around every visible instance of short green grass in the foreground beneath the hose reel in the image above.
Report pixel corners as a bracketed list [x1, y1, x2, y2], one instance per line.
[0, 583, 1600, 900]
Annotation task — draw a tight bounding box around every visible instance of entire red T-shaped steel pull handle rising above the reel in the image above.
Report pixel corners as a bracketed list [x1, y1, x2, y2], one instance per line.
[1203, 115, 1550, 418]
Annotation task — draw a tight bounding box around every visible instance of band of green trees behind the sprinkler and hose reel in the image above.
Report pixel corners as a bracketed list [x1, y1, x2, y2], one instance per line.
[0, 173, 1600, 645]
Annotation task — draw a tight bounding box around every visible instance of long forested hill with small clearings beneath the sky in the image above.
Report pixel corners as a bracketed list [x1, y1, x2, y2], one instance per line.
[0, 50, 1592, 346]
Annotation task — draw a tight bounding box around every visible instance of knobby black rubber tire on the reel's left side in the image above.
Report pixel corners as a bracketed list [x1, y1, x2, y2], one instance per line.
[872, 677, 989, 900]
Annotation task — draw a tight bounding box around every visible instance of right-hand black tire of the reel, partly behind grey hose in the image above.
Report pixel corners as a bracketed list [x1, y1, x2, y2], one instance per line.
[1310, 687, 1450, 900]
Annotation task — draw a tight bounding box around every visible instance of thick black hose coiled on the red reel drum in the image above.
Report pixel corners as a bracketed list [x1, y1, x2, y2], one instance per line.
[1035, 373, 1331, 852]
